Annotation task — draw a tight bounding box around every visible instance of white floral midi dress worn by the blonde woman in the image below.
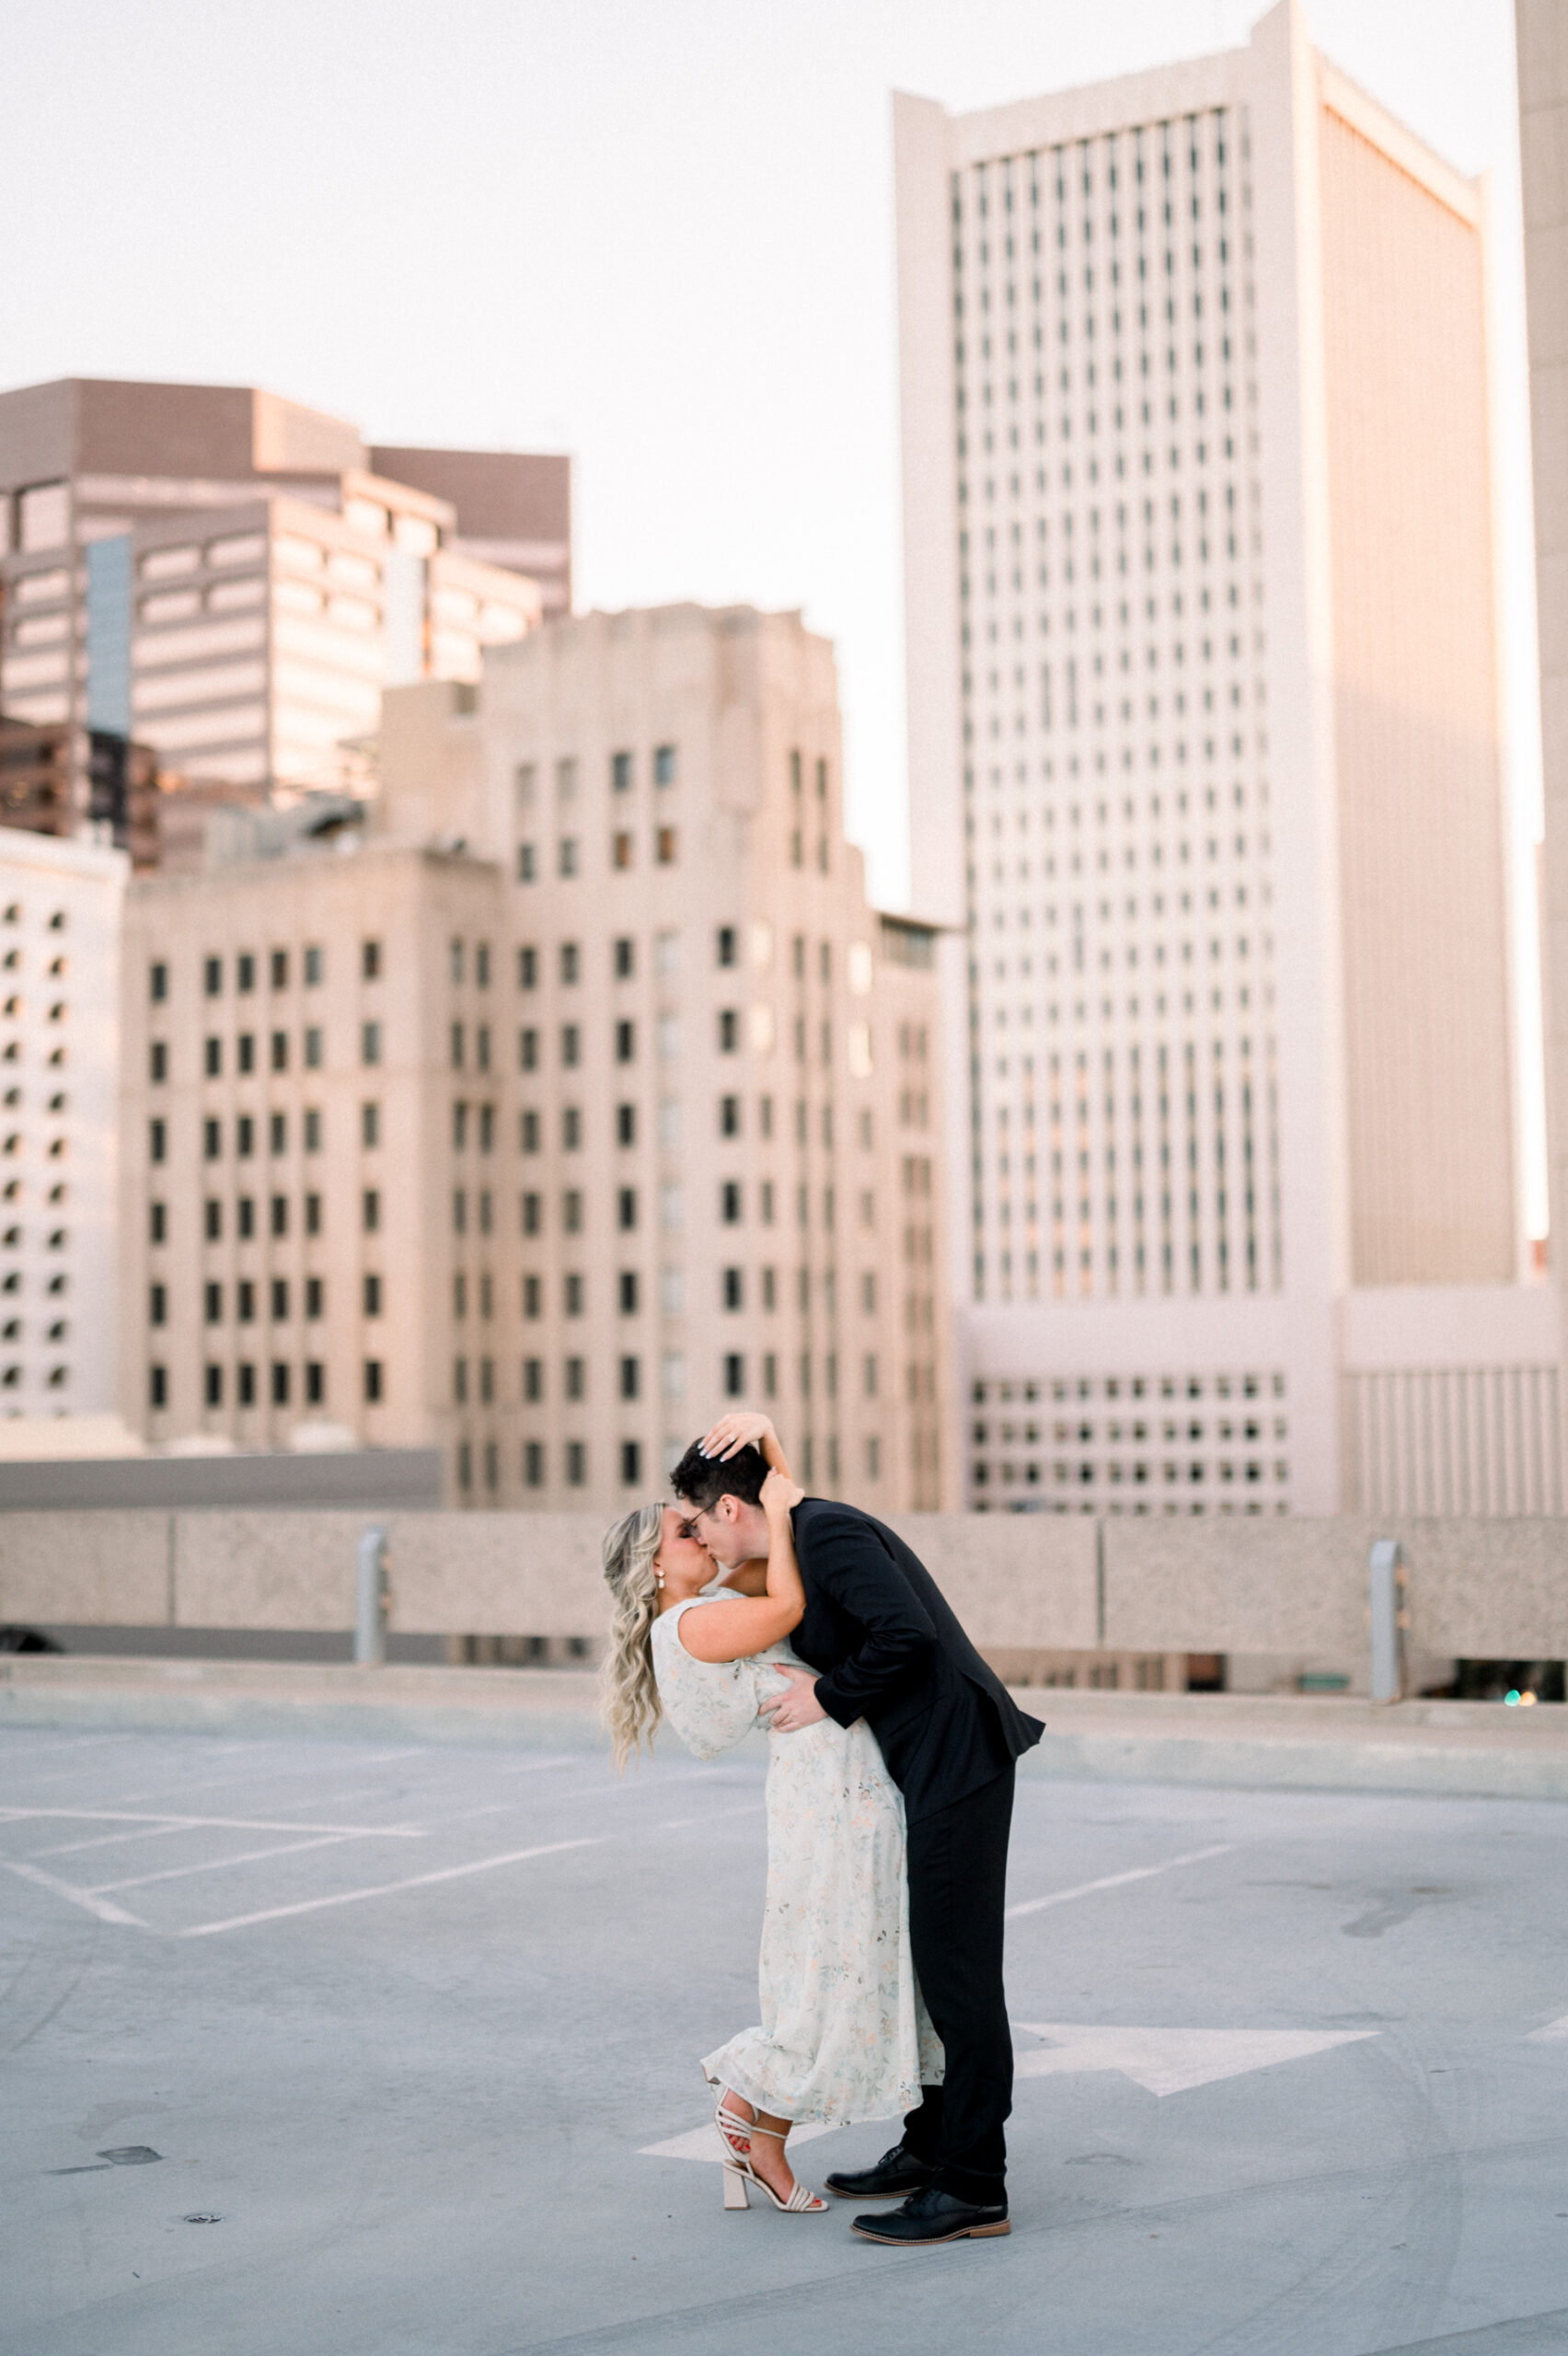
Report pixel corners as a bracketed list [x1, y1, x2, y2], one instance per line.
[652, 1595, 944, 2125]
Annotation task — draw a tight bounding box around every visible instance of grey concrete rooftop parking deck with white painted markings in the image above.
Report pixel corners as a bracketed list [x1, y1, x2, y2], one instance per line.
[0, 1717, 1568, 2356]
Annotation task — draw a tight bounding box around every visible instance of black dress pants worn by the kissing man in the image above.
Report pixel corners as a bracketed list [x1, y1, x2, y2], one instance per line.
[904, 1767, 1015, 2203]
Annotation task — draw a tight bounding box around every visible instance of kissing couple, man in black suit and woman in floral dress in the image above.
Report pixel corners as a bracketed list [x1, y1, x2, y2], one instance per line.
[603, 1414, 1043, 2247]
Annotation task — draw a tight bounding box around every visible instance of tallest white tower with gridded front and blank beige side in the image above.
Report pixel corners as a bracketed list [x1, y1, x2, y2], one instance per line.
[894, 0, 1561, 1513]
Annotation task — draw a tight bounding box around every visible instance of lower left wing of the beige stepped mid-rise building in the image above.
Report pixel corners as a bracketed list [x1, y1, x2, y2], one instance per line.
[118, 838, 506, 1498]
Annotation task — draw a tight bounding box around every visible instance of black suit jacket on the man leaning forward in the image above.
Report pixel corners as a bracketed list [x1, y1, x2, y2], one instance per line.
[789, 1496, 1045, 1823]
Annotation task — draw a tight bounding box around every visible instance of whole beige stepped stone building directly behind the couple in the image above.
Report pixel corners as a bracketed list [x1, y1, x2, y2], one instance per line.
[122, 606, 953, 1510]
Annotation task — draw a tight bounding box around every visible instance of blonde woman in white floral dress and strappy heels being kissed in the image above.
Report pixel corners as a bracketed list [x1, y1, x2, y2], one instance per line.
[605, 1427, 941, 2212]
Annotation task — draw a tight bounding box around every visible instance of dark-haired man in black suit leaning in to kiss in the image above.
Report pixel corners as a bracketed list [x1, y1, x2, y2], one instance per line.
[671, 1418, 1043, 2247]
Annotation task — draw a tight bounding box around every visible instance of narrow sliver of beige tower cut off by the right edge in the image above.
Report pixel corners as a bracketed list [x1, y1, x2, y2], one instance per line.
[1516, 0, 1568, 1479]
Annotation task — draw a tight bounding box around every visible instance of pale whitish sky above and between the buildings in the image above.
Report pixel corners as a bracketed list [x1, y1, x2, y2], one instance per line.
[0, 0, 1544, 1230]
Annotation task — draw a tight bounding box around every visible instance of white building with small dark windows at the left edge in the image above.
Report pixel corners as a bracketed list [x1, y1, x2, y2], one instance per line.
[0, 827, 127, 1416]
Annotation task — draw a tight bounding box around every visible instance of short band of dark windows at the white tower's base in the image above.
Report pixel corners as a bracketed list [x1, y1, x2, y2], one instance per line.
[968, 1373, 1290, 1513]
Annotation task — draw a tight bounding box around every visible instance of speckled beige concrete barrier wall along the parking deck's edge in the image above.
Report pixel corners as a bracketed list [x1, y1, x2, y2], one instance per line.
[0, 1510, 1568, 1661]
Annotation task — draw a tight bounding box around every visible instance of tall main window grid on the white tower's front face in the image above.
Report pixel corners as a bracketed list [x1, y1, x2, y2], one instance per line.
[951, 109, 1281, 1300]
